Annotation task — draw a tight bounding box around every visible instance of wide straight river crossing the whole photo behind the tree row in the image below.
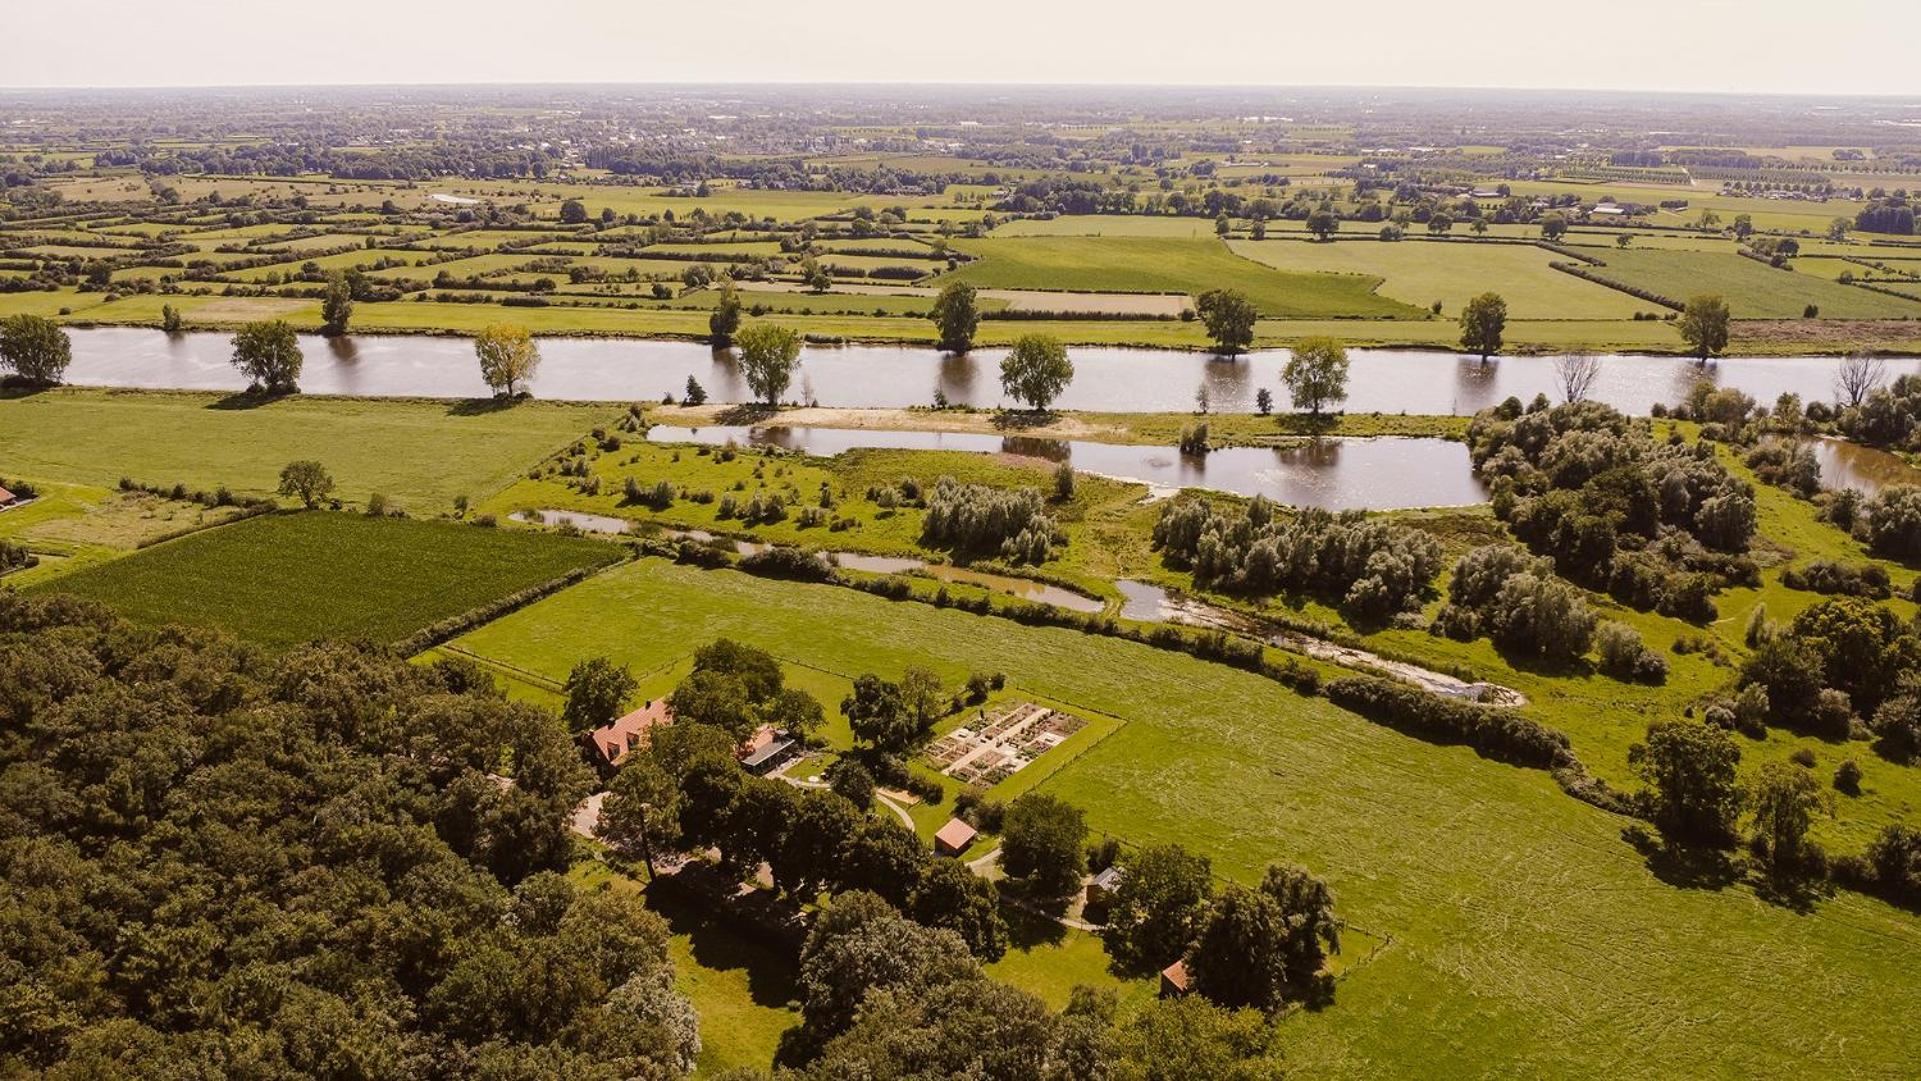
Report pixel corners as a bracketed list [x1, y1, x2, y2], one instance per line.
[67, 326, 1921, 415]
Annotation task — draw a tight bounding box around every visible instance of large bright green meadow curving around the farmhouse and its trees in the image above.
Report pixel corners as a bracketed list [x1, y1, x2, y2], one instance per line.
[445, 561, 1921, 1077]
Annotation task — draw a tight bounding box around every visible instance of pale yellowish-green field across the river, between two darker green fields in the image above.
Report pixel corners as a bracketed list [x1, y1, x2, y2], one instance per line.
[1229, 240, 1660, 319]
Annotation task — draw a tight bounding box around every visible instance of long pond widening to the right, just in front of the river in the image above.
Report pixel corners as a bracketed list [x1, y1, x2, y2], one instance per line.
[647, 424, 1487, 511]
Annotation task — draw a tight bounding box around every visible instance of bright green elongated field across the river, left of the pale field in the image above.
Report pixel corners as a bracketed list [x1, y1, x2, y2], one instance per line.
[941, 236, 1423, 319]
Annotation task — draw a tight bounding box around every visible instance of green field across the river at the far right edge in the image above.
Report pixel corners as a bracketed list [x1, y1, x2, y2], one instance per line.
[1587, 248, 1921, 319]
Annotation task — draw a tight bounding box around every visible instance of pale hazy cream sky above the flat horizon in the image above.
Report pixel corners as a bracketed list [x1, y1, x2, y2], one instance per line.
[11, 0, 1921, 96]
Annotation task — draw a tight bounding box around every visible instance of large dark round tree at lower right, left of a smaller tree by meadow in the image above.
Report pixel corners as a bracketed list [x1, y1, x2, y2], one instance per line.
[1627, 720, 1740, 845]
